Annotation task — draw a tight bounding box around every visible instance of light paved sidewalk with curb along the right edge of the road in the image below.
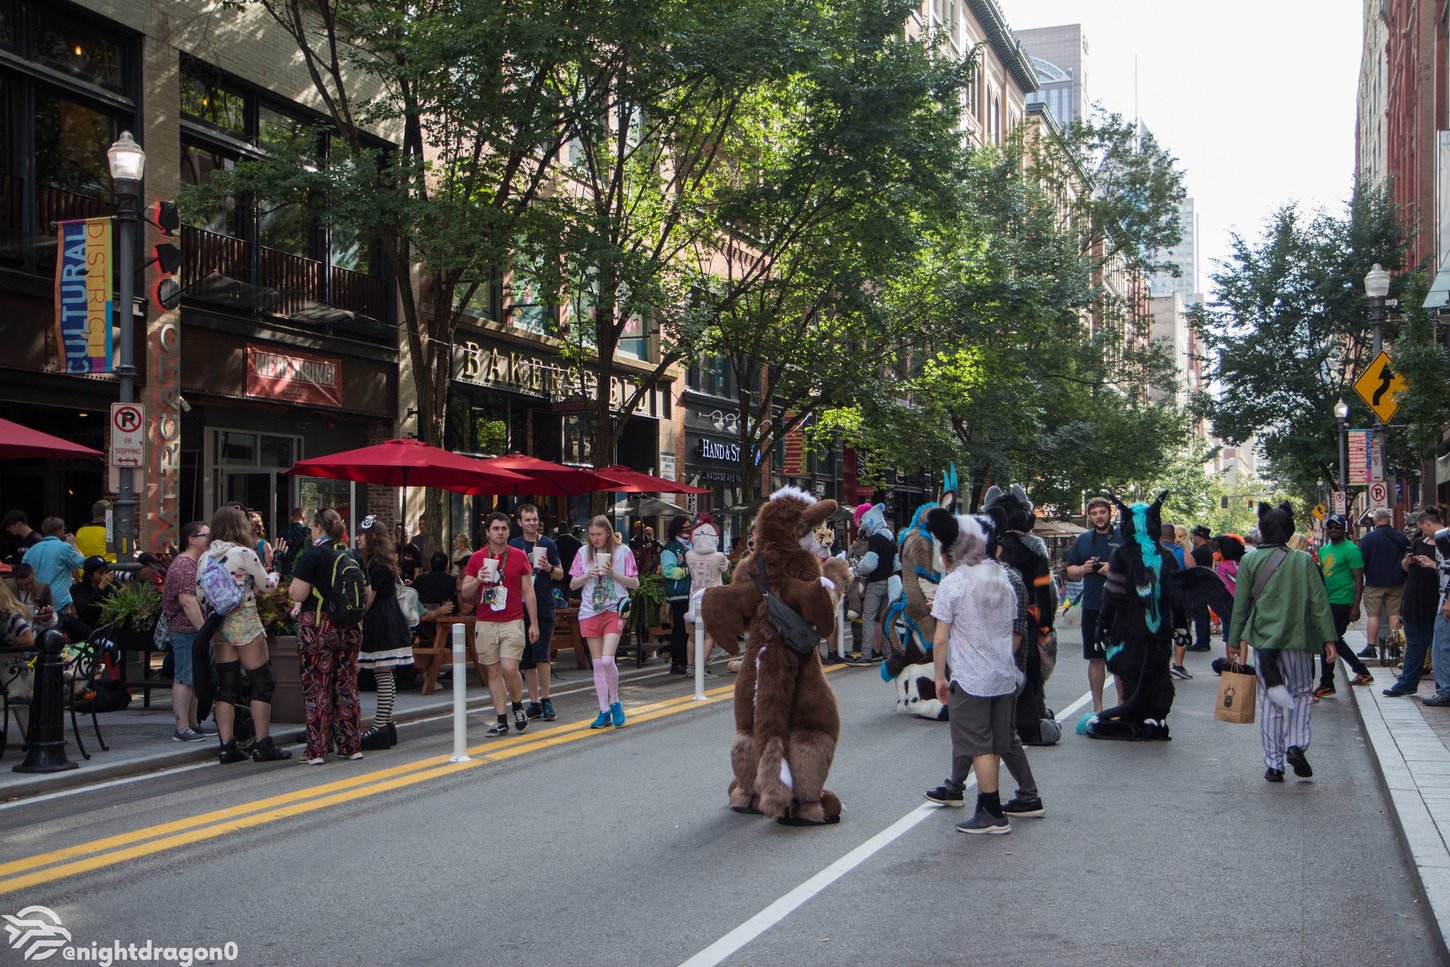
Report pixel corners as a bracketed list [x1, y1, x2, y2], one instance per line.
[1338, 629, 1450, 947]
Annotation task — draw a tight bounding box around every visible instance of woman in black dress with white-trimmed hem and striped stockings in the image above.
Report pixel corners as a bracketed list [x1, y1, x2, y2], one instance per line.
[358, 515, 413, 751]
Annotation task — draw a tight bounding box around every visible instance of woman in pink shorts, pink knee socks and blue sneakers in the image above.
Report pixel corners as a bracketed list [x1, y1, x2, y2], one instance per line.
[568, 515, 639, 729]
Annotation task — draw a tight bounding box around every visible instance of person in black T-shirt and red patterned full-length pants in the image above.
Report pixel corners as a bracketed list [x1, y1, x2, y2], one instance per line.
[287, 507, 363, 765]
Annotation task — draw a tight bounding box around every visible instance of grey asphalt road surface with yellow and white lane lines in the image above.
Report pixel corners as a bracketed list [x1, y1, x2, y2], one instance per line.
[0, 649, 1441, 967]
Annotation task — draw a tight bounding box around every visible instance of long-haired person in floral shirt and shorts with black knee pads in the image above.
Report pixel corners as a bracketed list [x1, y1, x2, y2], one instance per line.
[199, 506, 291, 764]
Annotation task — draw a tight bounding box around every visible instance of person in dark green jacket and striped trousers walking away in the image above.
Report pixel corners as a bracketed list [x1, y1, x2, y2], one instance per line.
[1224, 503, 1335, 783]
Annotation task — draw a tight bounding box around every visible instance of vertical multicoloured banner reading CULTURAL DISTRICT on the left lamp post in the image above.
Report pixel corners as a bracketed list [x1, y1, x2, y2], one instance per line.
[55, 219, 115, 374]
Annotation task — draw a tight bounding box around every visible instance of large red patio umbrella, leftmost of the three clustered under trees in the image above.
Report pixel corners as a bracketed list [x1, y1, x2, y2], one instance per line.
[287, 439, 531, 494]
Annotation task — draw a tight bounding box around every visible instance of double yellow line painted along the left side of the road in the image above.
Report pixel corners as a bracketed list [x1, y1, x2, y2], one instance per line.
[0, 684, 735, 895]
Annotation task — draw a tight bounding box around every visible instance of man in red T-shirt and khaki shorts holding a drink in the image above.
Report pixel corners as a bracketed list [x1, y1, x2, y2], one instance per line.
[463, 512, 539, 736]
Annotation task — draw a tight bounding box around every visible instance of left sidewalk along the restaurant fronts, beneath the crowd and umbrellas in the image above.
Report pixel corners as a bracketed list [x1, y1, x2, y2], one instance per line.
[0, 658, 693, 802]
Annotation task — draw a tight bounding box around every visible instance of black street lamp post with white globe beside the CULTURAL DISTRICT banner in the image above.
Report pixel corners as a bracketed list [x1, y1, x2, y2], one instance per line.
[106, 130, 146, 564]
